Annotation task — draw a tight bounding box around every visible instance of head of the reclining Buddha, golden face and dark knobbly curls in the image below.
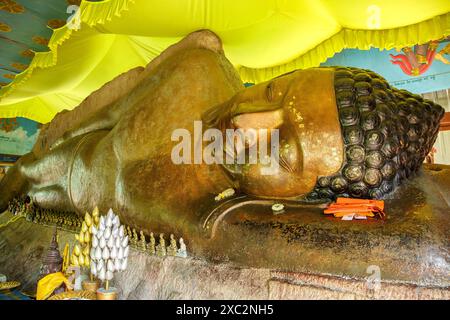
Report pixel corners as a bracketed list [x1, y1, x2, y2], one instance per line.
[203, 68, 443, 199]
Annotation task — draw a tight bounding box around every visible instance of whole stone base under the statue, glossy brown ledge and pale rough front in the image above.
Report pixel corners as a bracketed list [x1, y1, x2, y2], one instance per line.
[0, 166, 450, 299]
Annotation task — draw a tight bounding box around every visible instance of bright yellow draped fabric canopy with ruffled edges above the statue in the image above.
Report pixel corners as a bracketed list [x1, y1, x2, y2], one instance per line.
[0, 0, 450, 123]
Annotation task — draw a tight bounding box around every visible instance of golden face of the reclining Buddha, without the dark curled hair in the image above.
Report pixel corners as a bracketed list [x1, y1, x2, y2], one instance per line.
[203, 69, 344, 199]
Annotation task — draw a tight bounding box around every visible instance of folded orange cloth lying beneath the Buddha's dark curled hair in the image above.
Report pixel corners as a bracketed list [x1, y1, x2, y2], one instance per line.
[323, 198, 386, 219]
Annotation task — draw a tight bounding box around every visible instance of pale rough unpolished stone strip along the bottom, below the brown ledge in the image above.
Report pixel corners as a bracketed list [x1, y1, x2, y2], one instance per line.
[114, 252, 450, 300]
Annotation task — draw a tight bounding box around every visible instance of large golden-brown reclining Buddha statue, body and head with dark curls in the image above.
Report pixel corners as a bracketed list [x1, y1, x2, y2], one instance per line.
[0, 31, 444, 244]
